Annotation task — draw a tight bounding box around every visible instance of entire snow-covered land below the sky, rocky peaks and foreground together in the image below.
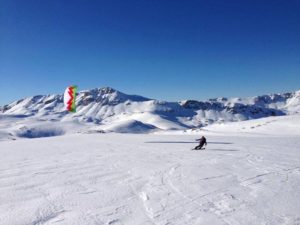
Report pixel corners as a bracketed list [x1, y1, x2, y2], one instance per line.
[0, 88, 300, 225]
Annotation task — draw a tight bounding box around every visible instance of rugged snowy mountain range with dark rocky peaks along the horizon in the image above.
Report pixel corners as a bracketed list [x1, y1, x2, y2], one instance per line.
[0, 87, 300, 132]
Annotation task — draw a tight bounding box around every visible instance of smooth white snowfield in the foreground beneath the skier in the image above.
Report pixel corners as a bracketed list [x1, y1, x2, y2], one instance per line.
[0, 116, 300, 225]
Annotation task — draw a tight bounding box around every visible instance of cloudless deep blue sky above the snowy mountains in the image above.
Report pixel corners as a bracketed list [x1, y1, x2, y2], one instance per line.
[0, 0, 300, 105]
